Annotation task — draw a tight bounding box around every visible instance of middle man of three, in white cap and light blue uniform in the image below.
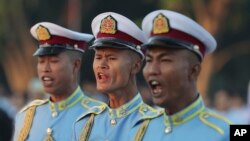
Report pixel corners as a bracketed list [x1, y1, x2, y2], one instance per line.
[74, 12, 159, 141]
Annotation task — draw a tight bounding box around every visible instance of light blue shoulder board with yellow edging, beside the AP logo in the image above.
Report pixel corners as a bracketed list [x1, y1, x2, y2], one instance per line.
[199, 111, 232, 135]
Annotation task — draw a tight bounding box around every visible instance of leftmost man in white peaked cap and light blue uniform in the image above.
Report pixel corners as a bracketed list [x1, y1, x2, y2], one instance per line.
[14, 22, 93, 141]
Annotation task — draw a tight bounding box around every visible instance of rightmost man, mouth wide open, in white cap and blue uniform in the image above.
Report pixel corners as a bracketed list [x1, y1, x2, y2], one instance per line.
[142, 10, 230, 141]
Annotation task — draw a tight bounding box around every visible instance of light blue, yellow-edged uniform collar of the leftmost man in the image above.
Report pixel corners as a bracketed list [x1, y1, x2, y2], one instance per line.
[49, 86, 84, 112]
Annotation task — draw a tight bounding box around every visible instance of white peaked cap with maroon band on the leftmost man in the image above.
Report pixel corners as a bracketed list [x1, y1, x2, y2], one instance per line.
[30, 22, 94, 56]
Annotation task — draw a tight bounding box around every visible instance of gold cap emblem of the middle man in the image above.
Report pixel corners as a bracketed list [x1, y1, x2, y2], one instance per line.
[100, 16, 117, 34]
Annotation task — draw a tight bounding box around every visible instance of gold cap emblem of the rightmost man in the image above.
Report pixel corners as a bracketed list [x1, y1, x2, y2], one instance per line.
[153, 13, 169, 34]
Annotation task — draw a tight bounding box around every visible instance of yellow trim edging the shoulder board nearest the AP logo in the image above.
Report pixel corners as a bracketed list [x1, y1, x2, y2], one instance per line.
[199, 111, 232, 135]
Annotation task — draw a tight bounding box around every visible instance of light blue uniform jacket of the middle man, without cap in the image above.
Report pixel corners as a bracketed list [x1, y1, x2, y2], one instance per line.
[73, 94, 162, 141]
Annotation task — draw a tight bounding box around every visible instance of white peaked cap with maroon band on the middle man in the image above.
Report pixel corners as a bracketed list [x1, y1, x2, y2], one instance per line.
[90, 12, 147, 58]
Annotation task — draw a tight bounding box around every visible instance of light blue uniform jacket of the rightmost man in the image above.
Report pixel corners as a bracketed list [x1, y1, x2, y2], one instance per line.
[140, 97, 230, 141]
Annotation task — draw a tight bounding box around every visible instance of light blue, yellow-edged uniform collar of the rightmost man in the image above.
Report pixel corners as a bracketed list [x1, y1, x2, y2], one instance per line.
[164, 96, 205, 126]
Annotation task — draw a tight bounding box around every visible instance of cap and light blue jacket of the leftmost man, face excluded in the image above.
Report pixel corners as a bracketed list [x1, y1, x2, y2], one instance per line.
[14, 22, 93, 141]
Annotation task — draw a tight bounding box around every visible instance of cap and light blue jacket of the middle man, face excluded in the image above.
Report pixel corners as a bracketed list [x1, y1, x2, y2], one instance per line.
[73, 12, 162, 141]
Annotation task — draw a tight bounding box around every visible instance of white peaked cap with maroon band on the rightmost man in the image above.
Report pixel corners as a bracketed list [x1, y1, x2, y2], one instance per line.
[142, 10, 217, 59]
